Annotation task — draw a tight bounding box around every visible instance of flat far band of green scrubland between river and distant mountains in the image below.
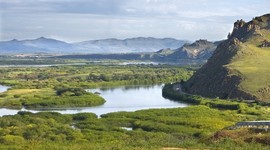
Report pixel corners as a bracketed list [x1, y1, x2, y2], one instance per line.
[0, 65, 193, 89]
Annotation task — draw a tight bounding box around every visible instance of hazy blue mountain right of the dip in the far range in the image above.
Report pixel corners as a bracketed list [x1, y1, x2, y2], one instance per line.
[74, 37, 187, 53]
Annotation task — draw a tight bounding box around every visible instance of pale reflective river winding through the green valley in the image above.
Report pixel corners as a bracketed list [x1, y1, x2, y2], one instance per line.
[0, 85, 187, 116]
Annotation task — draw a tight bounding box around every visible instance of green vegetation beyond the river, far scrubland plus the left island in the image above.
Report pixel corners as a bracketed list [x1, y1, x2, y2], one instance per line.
[0, 65, 192, 108]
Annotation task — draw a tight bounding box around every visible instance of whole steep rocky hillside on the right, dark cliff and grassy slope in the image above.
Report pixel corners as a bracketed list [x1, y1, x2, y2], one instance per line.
[184, 14, 270, 101]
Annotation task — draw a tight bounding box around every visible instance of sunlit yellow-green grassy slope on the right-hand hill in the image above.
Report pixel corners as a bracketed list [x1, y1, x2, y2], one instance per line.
[227, 30, 270, 101]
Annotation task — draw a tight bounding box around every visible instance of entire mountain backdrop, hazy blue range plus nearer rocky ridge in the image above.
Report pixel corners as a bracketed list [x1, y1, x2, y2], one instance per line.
[0, 37, 219, 64]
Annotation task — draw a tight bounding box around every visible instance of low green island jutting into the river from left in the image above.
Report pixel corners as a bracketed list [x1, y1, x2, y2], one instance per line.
[0, 88, 105, 109]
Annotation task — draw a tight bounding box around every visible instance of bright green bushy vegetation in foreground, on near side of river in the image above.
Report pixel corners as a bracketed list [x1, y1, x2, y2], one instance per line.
[0, 99, 270, 150]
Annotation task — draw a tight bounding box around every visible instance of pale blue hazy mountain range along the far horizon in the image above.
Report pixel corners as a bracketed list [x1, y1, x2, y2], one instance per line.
[0, 37, 188, 55]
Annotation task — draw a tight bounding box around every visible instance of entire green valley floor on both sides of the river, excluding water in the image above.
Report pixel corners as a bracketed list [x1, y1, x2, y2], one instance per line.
[0, 65, 270, 150]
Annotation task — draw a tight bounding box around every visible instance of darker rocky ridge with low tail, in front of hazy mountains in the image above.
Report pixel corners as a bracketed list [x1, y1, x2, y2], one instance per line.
[59, 40, 219, 63]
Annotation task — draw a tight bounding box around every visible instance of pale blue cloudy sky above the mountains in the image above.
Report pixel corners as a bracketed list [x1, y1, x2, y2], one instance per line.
[0, 0, 270, 42]
